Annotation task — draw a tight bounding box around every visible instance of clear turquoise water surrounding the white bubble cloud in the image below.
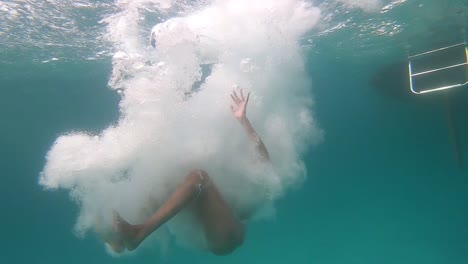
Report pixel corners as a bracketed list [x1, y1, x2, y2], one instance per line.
[0, 2, 468, 264]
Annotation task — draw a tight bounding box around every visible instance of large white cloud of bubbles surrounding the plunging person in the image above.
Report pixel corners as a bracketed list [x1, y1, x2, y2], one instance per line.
[40, 0, 322, 252]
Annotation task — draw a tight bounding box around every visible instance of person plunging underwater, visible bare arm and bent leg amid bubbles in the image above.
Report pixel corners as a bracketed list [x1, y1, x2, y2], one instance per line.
[106, 90, 270, 255]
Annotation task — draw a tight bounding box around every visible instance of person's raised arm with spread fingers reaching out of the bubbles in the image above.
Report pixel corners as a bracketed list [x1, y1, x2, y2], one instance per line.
[231, 89, 270, 161]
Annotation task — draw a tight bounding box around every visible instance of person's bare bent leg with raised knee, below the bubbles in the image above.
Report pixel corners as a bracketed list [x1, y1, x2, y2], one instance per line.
[114, 170, 244, 255]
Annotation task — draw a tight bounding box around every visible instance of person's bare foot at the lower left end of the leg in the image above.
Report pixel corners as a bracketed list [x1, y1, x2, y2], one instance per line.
[111, 211, 141, 251]
